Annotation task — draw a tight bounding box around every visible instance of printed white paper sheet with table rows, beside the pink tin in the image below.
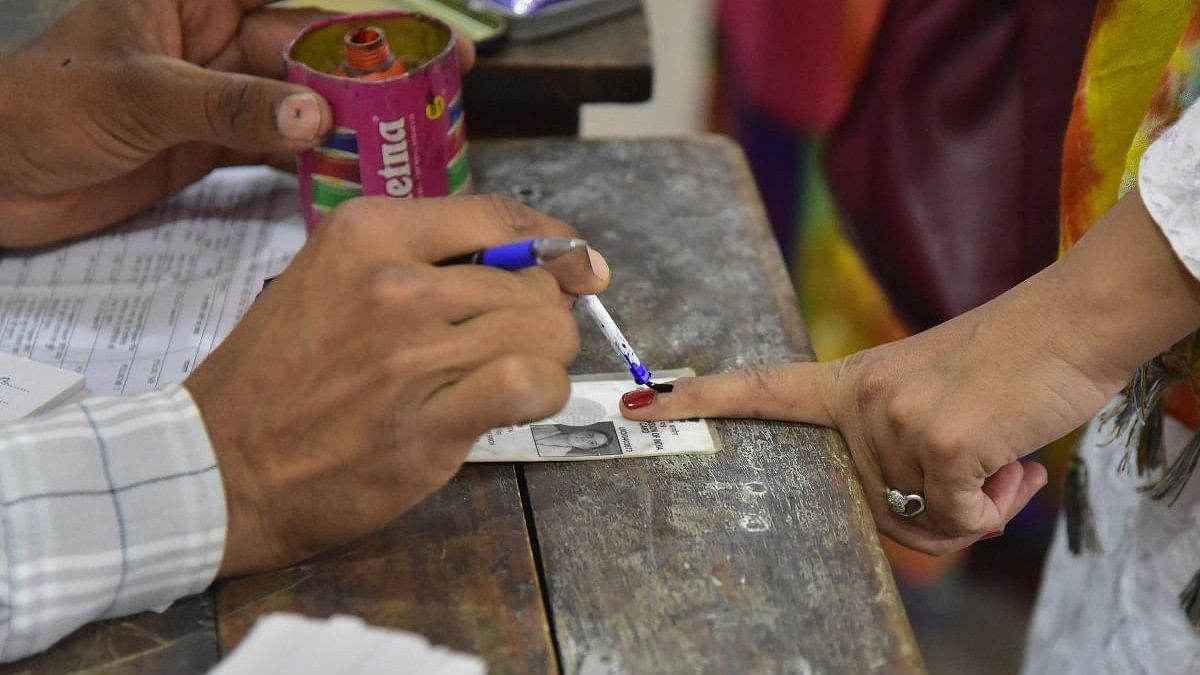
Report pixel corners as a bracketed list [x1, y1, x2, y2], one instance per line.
[0, 168, 305, 394]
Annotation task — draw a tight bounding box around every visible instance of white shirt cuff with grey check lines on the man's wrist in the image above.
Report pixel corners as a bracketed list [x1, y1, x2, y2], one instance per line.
[0, 384, 226, 661]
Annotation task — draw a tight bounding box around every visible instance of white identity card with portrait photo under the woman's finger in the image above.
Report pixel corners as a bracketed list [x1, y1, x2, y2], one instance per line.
[467, 369, 721, 462]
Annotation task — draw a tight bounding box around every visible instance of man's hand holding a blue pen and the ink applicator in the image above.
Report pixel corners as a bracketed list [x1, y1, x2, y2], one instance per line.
[185, 197, 608, 575]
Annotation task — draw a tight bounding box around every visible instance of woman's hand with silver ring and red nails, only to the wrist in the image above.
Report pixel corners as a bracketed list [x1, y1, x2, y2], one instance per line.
[622, 299, 1099, 554]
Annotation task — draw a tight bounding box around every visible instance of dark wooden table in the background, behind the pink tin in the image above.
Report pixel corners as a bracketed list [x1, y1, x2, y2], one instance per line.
[0, 0, 654, 138]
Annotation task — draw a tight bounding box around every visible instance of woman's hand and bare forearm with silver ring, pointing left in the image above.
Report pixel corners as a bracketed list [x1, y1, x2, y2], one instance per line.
[622, 187, 1200, 554]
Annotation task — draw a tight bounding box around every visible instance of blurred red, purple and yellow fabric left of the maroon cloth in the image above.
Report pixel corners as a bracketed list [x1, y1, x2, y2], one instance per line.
[715, 0, 892, 359]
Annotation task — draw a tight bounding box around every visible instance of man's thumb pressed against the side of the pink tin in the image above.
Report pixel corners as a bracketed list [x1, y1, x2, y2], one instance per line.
[125, 56, 334, 153]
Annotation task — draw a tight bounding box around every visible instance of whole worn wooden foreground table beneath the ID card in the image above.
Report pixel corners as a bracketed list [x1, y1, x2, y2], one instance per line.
[4, 138, 923, 674]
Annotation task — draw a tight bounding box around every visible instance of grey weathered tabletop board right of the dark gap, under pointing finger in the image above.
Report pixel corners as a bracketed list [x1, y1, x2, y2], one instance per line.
[476, 138, 922, 674]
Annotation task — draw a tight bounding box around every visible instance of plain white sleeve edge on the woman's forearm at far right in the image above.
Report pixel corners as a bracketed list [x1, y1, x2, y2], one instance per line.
[1138, 100, 1200, 279]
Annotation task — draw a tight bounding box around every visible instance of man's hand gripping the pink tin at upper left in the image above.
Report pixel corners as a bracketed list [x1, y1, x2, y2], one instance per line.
[0, 0, 474, 246]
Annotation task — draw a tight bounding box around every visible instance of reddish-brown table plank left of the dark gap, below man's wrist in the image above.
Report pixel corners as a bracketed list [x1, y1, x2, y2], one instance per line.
[216, 465, 556, 675]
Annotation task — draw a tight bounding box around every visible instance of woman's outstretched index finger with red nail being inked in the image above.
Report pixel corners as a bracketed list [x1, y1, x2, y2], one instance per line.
[620, 363, 833, 426]
